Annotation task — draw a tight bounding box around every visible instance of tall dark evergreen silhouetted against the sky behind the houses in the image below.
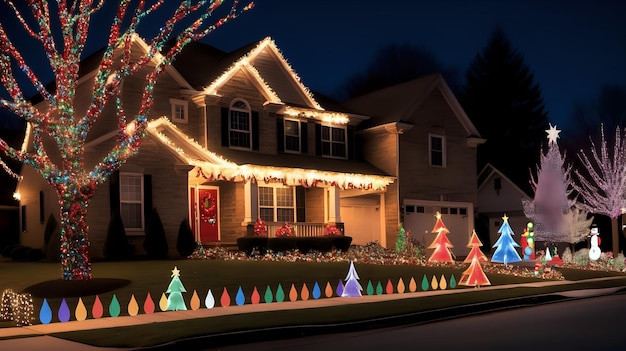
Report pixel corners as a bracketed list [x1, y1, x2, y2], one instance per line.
[459, 28, 548, 184]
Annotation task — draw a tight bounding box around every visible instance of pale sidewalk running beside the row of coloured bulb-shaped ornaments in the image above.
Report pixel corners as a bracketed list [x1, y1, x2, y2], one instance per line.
[0, 277, 622, 351]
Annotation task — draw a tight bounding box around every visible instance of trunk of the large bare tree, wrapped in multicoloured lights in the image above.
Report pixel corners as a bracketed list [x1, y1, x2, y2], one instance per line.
[59, 188, 93, 280]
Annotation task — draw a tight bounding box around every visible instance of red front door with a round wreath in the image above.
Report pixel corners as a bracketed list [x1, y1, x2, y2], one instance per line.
[189, 186, 220, 243]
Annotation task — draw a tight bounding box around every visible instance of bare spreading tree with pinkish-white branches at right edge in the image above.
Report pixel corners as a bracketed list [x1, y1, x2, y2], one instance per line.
[573, 126, 626, 255]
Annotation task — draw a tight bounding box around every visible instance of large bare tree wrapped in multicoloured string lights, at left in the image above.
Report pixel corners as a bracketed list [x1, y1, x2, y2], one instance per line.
[0, 0, 252, 280]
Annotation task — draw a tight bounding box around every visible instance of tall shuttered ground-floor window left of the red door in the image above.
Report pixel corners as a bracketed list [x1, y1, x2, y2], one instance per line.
[120, 173, 144, 230]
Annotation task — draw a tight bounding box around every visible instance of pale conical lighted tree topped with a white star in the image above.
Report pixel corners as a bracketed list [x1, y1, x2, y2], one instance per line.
[522, 125, 575, 243]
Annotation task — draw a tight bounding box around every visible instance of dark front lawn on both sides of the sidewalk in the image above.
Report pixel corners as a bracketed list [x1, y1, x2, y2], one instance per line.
[0, 249, 626, 347]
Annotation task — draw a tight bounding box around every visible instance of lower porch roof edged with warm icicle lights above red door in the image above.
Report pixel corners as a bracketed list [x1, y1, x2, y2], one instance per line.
[147, 117, 394, 190]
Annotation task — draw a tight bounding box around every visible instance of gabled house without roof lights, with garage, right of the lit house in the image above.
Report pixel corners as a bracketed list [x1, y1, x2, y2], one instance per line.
[345, 74, 484, 256]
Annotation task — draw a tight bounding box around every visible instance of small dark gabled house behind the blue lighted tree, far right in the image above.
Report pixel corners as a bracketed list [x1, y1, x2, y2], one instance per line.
[476, 163, 532, 251]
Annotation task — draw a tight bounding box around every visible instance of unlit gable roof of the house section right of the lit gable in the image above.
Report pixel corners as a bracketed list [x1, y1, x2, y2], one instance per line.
[344, 73, 480, 138]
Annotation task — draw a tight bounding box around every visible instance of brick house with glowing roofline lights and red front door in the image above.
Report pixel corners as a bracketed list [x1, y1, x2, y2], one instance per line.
[17, 37, 392, 257]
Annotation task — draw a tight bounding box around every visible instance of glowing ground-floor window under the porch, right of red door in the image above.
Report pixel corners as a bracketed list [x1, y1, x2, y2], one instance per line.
[259, 186, 296, 222]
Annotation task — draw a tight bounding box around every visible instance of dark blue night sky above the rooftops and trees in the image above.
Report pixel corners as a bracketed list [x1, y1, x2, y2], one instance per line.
[0, 0, 626, 137]
